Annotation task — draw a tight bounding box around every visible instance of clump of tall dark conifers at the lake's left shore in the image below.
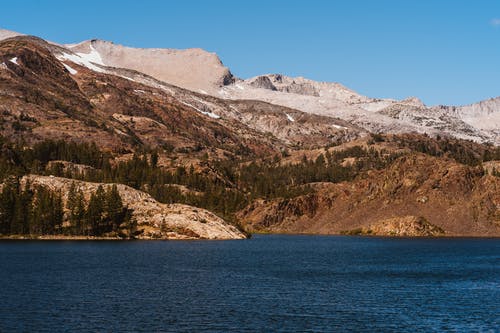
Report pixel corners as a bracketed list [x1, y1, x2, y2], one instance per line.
[0, 177, 137, 238]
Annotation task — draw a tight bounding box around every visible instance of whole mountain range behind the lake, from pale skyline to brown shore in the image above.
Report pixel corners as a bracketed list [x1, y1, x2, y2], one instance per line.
[0, 30, 500, 238]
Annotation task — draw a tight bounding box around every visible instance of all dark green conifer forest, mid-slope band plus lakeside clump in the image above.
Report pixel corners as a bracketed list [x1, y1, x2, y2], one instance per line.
[0, 135, 500, 236]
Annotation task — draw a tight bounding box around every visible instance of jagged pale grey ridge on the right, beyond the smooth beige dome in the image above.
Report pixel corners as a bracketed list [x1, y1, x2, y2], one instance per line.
[218, 74, 500, 145]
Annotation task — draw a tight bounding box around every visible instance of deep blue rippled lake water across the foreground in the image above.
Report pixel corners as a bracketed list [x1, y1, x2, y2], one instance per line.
[0, 236, 500, 332]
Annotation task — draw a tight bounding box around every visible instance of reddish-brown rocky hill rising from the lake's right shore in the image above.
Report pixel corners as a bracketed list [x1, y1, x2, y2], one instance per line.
[239, 154, 500, 236]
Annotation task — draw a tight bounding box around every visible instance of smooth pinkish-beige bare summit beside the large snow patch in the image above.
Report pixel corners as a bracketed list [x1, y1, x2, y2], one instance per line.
[67, 40, 233, 93]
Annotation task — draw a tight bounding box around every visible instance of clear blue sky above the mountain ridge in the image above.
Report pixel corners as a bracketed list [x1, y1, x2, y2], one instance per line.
[0, 0, 500, 105]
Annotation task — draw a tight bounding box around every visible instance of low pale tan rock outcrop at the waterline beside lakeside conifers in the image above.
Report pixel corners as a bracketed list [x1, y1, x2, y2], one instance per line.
[22, 175, 246, 239]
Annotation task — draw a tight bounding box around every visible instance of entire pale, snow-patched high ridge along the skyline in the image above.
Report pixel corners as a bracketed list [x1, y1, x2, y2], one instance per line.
[0, 30, 500, 145]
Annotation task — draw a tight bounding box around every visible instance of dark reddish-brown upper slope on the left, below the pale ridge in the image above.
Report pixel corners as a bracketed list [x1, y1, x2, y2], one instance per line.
[0, 37, 363, 154]
